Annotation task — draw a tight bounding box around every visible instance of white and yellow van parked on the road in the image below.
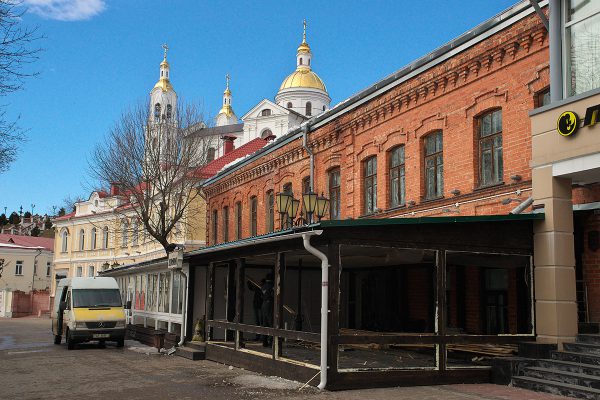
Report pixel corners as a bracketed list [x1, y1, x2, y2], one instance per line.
[52, 277, 130, 350]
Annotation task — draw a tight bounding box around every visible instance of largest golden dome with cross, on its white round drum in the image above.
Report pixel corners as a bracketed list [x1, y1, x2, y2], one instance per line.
[275, 20, 331, 117]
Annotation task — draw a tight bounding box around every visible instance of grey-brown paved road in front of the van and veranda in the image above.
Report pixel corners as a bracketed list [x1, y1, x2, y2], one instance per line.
[0, 318, 566, 400]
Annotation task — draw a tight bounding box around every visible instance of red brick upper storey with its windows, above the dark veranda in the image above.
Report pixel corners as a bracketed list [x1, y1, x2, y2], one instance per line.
[204, 14, 549, 244]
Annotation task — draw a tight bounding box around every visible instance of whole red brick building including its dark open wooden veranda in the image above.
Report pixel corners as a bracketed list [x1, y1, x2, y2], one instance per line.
[186, 2, 549, 388]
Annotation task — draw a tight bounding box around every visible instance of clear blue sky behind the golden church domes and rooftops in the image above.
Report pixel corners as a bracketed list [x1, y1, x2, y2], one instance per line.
[0, 0, 516, 217]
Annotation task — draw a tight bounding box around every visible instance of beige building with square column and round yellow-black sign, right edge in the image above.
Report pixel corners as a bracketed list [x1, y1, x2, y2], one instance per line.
[531, 0, 600, 343]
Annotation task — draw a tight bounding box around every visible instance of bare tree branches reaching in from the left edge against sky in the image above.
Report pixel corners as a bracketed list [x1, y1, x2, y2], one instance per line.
[0, 0, 41, 173]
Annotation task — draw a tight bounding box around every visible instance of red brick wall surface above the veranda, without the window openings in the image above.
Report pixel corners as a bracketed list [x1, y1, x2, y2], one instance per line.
[205, 15, 549, 245]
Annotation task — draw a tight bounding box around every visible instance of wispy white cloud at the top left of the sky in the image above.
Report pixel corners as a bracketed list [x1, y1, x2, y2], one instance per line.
[23, 0, 106, 21]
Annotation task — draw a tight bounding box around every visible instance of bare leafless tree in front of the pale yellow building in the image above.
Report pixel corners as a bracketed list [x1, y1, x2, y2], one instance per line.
[90, 104, 214, 252]
